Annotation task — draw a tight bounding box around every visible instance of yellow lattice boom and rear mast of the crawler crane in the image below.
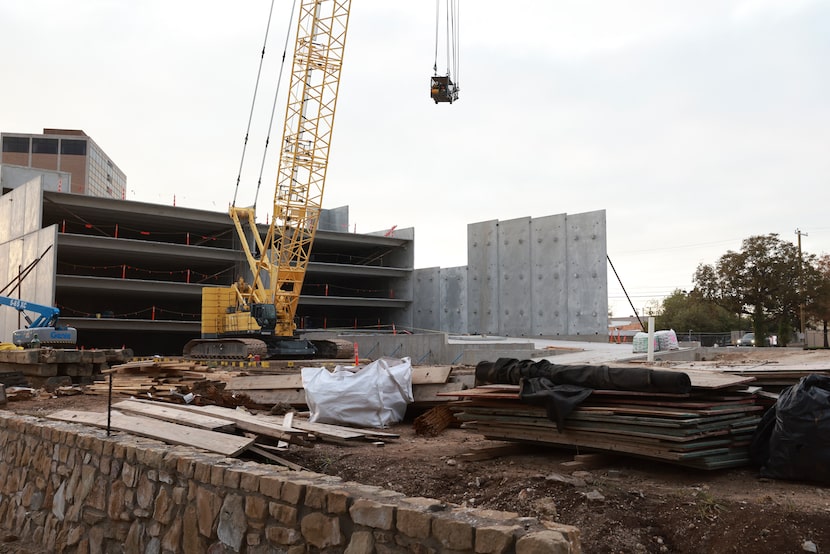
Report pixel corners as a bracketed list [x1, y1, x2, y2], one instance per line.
[230, 0, 351, 336]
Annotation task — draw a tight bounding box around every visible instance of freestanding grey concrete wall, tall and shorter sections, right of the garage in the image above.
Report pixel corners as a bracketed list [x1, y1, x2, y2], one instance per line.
[414, 210, 608, 340]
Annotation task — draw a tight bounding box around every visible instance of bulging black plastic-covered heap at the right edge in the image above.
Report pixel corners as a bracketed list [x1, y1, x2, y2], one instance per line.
[750, 374, 830, 484]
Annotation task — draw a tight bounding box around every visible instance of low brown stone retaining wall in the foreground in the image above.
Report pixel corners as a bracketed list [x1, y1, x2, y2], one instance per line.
[0, 412, 579, 554]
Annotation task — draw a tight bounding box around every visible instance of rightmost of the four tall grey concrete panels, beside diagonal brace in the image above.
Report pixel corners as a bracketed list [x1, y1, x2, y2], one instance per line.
[567, 210, 608, 335]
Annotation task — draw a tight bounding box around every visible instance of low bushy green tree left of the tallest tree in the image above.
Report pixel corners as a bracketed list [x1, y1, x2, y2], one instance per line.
[657, 289, 741, 333]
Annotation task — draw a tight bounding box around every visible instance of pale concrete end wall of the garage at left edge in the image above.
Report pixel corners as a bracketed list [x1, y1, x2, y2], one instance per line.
[0, 177, 57, 342]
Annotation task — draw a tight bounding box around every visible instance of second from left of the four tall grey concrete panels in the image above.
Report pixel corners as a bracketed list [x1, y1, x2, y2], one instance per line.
[498, 217, 532, 336]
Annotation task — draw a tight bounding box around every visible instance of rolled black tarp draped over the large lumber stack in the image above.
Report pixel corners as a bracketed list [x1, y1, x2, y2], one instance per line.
[476, 358, 692, 431]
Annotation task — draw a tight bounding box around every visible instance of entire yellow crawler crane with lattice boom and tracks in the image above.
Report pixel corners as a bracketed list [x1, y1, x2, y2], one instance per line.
[184, 0, 353, 359]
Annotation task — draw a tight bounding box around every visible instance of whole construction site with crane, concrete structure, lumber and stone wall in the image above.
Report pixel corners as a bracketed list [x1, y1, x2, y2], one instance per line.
[0, 0, 830, 554]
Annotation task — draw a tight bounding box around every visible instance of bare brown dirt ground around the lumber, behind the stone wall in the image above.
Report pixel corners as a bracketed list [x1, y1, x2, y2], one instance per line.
[0, 348, 830, 554]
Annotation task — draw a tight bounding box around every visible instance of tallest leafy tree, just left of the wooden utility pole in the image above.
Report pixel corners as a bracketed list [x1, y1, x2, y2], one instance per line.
[694, 233, 809, 345]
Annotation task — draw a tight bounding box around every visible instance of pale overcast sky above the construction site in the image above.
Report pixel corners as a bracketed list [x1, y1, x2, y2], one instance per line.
[0, 0, 830, 315]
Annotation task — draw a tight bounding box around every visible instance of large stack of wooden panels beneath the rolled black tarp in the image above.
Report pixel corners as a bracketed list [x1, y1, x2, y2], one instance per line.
[446, 371, 763, 469]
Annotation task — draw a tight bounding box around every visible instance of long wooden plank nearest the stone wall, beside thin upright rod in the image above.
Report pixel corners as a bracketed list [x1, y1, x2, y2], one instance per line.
[47, 410, 254, 456]
